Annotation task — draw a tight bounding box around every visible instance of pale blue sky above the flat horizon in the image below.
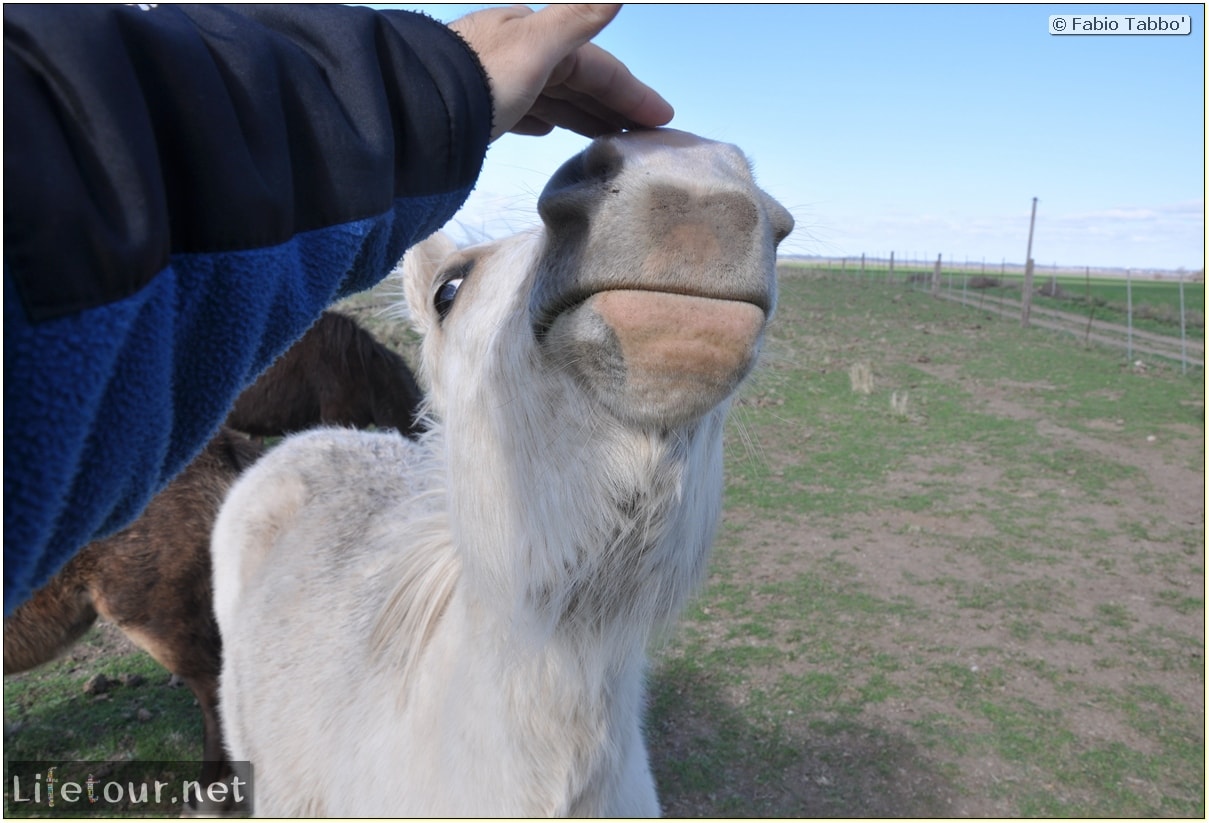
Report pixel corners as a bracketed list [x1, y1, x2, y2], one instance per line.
[384, 4, 1205, 271]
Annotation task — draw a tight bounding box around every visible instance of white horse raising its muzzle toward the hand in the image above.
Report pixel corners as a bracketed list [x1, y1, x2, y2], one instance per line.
[213, 129, 793, 817]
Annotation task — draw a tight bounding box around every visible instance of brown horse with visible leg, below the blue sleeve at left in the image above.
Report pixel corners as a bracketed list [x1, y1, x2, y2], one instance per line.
[4, 430, 261, 802]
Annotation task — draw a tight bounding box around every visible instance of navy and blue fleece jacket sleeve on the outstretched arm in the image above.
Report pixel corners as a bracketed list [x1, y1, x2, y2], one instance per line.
[4, 5, 492, 614]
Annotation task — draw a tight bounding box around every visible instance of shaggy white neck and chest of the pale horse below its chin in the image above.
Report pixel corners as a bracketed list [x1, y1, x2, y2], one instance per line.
[367, 389, 723, 816]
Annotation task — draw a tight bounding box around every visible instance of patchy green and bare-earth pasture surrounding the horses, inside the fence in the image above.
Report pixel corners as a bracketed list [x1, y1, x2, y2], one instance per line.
[5, 269, 1205, 817]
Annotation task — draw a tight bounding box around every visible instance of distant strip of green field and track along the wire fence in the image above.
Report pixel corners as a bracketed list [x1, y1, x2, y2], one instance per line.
[781, 255, 1205, 373]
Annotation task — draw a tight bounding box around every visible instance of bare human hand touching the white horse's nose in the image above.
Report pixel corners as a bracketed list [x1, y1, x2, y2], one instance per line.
[450, 4, 673, 140]
